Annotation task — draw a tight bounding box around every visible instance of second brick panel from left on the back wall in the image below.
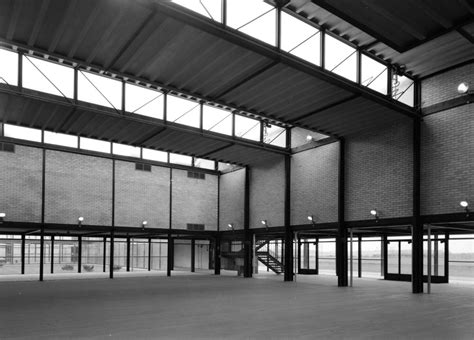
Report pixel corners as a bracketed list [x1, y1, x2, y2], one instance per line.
[45, 150, 112, 226]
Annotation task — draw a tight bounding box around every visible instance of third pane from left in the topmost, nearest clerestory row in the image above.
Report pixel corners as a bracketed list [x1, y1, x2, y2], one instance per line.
[281, 12, 321, 65]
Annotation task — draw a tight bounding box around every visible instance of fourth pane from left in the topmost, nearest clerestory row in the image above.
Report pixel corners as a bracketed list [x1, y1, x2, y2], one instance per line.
[324, 34, 357, 81]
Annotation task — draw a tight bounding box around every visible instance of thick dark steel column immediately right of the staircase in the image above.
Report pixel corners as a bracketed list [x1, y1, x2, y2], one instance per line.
[284, 155, 294, 281]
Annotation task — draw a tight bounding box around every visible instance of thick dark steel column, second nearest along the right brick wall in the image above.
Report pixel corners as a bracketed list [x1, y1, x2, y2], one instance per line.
[336, 138, 347, 287]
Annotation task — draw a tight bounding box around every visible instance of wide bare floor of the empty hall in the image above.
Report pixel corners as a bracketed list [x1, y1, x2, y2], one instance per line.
[0, 273, 474, 339]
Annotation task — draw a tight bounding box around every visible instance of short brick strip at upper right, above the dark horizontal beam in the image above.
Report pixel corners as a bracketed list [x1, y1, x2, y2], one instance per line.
[421, 63, 474, 107]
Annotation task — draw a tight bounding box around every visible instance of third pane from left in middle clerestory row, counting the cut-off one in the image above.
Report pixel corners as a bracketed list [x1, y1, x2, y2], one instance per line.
[77, 70, 122, 110]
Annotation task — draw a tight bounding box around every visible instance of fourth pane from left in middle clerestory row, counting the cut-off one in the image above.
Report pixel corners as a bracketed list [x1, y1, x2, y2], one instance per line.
[125, 84, 165, 119]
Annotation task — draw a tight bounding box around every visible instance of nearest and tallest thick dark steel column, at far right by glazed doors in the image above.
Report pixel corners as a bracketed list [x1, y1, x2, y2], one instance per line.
[412, 117, 423, 293]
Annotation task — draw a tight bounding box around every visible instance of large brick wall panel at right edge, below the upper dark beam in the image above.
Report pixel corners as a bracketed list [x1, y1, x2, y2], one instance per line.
[421, 104, 474, 214]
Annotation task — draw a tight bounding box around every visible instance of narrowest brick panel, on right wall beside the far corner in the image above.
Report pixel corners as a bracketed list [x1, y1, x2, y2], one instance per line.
[219, 169, 245, 230]
